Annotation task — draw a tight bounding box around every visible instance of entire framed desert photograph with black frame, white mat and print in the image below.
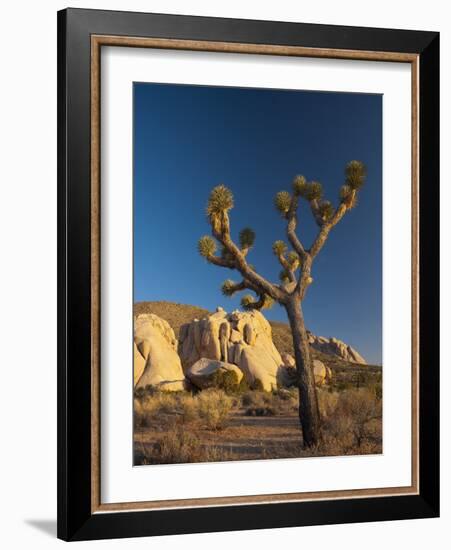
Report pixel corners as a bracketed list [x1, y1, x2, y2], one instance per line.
[58, 9, 439, 540]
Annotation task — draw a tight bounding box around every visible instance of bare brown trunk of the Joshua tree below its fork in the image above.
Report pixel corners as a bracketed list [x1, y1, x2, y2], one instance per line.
[285, 297, 321, 447]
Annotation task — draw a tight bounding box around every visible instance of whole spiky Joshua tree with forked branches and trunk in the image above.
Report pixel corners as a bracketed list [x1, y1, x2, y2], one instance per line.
[198, 160, 366, 447]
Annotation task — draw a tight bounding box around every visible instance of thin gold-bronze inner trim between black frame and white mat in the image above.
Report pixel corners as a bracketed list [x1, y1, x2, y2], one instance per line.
[91, 35, 419, 514]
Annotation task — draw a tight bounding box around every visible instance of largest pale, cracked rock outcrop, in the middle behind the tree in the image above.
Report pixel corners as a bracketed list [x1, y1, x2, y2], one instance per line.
[178, 308, 283, 391]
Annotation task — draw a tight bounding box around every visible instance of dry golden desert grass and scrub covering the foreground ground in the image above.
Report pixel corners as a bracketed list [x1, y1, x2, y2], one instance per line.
[135, 388, 382, 464]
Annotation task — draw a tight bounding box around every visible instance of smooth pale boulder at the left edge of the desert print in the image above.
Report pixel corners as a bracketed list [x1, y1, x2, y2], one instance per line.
[133, 313, 185, 391]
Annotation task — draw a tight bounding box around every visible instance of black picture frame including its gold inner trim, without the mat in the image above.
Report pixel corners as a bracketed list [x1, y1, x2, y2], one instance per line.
[58, 9, 439, 540]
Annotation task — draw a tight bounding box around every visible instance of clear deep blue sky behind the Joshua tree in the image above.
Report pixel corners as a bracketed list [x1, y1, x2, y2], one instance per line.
[134, 83, 382, 364]
